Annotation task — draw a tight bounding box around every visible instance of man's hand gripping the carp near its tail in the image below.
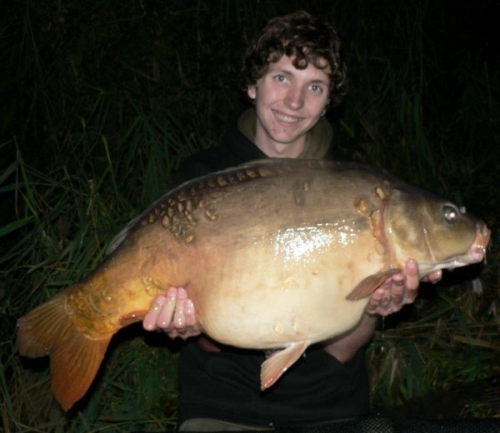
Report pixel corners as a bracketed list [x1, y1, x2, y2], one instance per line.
[142, 287, 200, 339]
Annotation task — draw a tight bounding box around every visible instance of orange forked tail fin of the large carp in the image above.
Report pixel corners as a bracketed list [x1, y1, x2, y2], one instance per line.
[17, 292, 112, 410]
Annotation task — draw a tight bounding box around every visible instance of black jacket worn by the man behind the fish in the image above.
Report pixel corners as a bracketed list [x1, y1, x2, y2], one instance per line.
[176, 116, 369, 427]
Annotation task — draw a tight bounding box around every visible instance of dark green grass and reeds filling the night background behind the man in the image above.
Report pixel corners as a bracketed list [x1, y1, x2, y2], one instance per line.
[0, 0, 500, 432]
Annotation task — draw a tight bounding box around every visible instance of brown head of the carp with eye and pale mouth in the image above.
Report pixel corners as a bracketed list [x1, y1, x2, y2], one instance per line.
[384, 185, 491, 277]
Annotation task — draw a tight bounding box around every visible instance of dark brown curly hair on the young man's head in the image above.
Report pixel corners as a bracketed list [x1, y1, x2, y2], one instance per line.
[241, 11, 348, 106]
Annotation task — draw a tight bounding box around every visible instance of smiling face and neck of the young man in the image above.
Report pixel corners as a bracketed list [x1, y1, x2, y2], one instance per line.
[248, 56, 330, 158]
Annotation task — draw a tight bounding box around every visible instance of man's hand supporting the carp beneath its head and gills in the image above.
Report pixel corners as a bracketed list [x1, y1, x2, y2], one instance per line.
[366, 259, 442, 316]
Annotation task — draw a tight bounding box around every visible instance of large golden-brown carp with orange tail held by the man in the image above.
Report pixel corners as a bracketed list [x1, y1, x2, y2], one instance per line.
[18, 159, 490, 409]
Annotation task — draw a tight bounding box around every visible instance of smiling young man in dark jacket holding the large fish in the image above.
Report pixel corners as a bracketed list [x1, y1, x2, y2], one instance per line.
[143, 12, 440, 431]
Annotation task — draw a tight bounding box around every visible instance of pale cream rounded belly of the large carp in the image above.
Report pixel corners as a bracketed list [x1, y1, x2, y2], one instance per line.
[188, 226, 383, 349]
